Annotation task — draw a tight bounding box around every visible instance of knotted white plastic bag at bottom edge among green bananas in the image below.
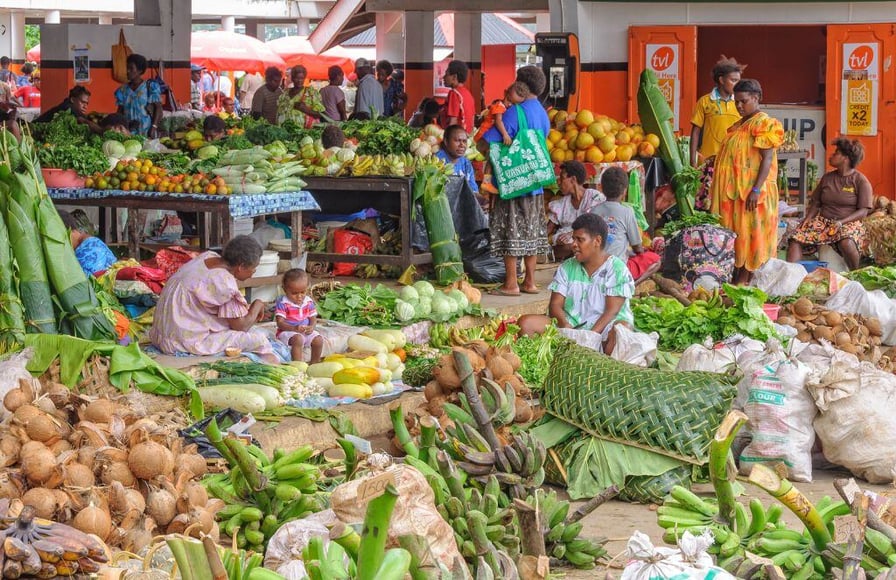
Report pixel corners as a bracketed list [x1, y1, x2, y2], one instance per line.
[622, 531, 735, 580]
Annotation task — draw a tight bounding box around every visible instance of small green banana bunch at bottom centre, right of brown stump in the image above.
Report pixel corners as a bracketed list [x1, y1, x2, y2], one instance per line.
[526, 489, 607, 570]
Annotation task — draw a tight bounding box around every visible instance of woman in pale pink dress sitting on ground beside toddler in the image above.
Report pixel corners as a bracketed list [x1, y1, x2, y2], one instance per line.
[149, 236, 278, 363]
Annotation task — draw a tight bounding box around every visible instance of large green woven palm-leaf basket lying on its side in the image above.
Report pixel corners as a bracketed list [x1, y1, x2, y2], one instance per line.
[541, 341, 737, 464]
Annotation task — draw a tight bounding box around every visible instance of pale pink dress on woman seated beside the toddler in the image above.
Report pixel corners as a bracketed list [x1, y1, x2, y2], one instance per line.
[149, 252, 274, 358]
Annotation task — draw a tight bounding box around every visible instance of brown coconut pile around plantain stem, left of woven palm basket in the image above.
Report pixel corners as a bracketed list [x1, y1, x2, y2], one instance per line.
[417, 340, 535, 425]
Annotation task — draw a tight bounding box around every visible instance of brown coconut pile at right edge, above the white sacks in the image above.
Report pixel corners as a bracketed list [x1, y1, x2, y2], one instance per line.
[777, 297, 896, 372]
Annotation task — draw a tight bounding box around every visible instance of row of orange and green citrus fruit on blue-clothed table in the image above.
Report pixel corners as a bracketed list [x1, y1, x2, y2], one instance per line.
[84, 159, 231, 195]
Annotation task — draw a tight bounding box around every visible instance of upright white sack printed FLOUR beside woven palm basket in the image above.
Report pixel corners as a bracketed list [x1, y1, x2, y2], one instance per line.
[740, 359, 818, 481]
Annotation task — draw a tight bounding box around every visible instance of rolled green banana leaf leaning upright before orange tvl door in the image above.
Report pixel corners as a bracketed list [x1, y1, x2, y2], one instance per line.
[638, 69, 694, 217]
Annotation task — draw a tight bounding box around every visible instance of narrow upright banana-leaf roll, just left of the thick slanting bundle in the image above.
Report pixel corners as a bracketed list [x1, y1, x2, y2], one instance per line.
[6, 179, 57, 334]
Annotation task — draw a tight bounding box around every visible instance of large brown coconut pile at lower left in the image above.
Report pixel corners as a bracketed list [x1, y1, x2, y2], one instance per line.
[0, 381, 223, 553]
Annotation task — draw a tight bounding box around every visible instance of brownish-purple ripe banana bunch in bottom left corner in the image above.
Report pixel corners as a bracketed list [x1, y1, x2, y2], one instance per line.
[0, 506, 108, 578]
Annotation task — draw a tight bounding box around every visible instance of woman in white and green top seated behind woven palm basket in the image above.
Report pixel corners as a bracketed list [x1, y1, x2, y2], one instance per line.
[518, 213, 635, 353]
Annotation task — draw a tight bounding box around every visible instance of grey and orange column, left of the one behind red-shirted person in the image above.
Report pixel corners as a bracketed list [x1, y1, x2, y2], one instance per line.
[404, 11, 435, 124]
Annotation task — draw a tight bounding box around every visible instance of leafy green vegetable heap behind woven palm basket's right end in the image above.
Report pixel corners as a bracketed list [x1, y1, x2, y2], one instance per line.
[632, 284, 783, 351]
